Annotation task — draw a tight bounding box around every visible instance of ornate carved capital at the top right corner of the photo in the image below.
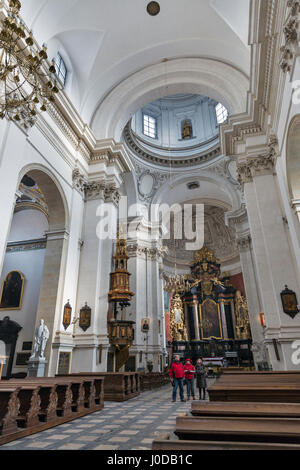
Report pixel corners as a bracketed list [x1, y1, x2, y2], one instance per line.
[280, 0, 300, 73]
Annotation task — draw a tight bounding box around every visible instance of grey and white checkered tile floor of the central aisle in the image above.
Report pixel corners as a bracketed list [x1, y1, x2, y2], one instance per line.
[0, 386, 211, 450]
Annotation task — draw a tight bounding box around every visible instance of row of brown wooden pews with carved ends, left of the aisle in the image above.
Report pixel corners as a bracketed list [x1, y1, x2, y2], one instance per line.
[0, 376, 104, 445]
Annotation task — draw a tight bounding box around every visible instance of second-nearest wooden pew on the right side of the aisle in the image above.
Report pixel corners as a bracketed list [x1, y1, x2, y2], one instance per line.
[175, 416, 300, 446]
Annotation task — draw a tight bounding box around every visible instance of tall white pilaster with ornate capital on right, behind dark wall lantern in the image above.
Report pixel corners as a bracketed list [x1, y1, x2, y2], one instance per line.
[239, 148, 300, 370]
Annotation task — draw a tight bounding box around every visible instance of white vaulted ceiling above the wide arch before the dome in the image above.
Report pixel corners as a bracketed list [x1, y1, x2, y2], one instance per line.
[21, 0, 250, 124]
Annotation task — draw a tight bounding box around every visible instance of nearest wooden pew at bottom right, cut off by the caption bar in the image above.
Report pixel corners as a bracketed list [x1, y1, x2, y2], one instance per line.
[152, 434, 299, 451]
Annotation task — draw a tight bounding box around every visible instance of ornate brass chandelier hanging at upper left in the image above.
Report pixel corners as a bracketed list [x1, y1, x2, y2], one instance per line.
[0, 0, 59, 128]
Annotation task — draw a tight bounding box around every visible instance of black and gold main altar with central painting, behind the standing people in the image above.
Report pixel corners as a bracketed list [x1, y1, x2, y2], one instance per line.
[169, 247, 253, 367]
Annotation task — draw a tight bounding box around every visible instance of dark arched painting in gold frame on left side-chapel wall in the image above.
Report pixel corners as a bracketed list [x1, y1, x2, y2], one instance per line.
[0, 271, 25, 310]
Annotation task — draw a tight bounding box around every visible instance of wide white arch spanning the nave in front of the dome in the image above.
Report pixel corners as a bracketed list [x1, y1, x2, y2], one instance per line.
[91, 58, 249, 142]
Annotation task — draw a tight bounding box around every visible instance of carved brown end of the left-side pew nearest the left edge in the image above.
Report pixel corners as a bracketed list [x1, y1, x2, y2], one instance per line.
[0, 384, 20, 436]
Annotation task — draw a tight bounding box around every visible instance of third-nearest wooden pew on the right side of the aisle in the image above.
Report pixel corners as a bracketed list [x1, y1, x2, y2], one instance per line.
[191, 401, 300, 418]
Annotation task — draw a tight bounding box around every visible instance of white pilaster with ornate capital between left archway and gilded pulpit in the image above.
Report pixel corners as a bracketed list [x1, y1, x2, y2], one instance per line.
[72, 181, 118, 372]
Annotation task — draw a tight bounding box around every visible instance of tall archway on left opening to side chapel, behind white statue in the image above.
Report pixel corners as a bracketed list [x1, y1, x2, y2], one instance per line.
[0, 165, 68, 375]
